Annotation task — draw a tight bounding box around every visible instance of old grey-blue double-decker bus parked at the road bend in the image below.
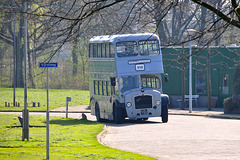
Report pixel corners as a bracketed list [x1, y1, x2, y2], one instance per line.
[89, 33, 169, 123]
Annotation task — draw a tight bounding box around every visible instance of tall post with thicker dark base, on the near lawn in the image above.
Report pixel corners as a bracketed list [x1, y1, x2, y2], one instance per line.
[22, 1, 29, 141]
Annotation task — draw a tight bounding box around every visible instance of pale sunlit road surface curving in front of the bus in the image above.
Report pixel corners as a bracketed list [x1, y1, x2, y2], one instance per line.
[99, 115, 240, 160]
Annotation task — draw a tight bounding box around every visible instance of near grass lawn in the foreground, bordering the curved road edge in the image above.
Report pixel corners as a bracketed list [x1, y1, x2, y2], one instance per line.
[0, 115, 156, 160]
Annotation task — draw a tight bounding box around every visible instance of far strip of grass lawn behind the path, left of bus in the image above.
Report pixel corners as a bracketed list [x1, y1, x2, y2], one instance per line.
[0, 88, 89, 111]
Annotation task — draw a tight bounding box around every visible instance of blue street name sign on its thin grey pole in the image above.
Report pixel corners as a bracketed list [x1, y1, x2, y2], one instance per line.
[39, 63, 58, 159]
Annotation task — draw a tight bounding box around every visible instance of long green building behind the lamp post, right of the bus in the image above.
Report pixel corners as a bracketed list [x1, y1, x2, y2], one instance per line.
[162, 46, 240, 107]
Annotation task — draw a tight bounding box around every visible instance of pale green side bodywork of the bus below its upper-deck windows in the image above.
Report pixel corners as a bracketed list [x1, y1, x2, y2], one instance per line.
[89, 58, 116, 120]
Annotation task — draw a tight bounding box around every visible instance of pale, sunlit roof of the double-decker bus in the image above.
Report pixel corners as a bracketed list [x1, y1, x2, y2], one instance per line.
[89, 33, 159, 43]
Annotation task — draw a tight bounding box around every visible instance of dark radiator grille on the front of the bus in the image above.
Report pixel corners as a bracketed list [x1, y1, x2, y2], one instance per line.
[135, 96, 152, 109]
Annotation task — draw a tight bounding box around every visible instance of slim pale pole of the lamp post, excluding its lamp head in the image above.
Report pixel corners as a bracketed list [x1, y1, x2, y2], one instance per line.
[189, 39, 192, 113]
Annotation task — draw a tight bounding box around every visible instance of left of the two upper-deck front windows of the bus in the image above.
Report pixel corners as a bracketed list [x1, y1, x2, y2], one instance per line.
[116, 41, 137, 57]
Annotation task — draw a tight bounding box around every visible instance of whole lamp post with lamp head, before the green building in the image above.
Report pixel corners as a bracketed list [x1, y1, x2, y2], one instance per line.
[187, 29, 197, 113]
